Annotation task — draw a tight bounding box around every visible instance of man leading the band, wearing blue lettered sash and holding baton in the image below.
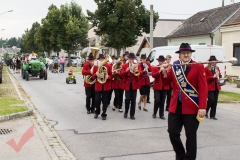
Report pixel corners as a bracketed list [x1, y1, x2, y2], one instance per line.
[161, 43, 207, 160]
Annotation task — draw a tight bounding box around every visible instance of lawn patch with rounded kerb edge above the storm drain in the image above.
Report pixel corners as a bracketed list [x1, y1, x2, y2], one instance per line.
[0, 99, 28, 116]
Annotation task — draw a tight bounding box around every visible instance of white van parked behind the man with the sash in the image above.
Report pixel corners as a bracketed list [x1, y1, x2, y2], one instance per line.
[148, 45, 226, 85]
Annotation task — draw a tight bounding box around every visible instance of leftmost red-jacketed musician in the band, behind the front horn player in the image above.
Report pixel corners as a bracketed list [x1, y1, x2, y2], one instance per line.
[82, 53, 95, 114]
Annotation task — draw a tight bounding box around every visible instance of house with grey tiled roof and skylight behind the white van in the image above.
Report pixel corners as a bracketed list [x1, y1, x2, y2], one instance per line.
[166, 3, 240, 46]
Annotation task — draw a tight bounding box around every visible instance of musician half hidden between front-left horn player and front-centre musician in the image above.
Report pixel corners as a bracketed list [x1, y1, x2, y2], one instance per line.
[112, 57, 123, 112]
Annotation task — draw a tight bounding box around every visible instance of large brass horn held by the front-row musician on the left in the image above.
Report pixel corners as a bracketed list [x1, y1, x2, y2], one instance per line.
[97, 54, 112, 84]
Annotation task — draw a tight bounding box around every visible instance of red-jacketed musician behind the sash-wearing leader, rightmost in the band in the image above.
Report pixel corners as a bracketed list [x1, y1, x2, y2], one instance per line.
[204, 56, 222, 120]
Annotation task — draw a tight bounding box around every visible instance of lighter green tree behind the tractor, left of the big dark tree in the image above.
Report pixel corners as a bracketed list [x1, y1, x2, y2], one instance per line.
[53, 1, 88, 65]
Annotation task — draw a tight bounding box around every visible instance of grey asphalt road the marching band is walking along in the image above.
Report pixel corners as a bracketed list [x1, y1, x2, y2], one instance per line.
[12, 69, 240, 160]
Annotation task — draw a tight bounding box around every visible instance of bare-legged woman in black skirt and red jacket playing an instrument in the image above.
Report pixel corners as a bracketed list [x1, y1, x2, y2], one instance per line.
[138, 54, 151, 112]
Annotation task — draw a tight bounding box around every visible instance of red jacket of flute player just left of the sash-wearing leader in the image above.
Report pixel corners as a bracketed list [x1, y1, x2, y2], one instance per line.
[152, 67, 169, 90]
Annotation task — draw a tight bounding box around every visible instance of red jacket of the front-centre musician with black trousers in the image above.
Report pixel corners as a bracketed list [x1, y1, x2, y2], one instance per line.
[120, 63, 142, 91]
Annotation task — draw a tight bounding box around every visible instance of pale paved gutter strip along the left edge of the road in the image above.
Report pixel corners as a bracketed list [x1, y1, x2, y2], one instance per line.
[8, 67, 76, 160]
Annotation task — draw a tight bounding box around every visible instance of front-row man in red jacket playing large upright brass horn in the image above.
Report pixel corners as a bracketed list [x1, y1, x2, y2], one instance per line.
[92, 54, 112, 120]
